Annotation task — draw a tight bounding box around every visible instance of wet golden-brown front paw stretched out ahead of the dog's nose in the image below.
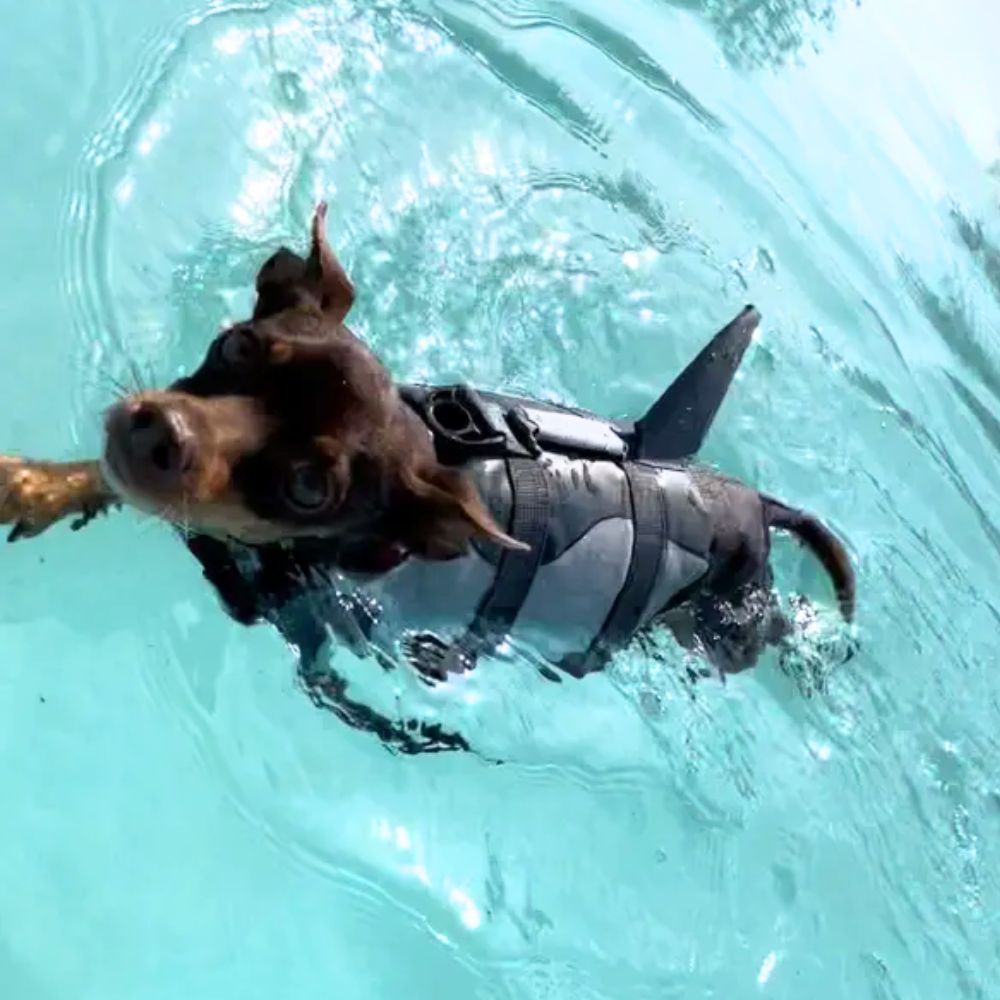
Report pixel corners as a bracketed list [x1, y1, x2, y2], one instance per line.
[0, 456, 119, 542]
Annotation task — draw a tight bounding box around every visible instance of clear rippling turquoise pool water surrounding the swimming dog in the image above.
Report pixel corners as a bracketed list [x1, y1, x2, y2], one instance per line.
[0, 0, 1000, 1000]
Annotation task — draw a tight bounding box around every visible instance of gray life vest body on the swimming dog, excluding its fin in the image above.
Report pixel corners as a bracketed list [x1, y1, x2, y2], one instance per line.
[258, 386, 711, 676]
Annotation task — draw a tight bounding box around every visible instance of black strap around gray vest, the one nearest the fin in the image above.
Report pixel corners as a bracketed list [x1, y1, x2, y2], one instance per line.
[560, 463, 669, 677]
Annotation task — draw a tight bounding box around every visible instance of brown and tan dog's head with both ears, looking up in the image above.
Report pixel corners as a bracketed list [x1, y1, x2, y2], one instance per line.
[104, 206, 518, 559]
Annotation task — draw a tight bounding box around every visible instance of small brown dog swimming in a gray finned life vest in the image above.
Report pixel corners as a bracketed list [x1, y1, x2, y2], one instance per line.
[0, 204, 855, 752]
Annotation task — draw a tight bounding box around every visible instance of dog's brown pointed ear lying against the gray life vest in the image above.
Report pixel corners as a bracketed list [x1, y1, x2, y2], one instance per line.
[400, 466, 528, 560]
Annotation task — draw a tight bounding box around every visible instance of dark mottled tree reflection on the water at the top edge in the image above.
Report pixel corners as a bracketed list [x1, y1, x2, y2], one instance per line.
[669, 0, 861, 69]
